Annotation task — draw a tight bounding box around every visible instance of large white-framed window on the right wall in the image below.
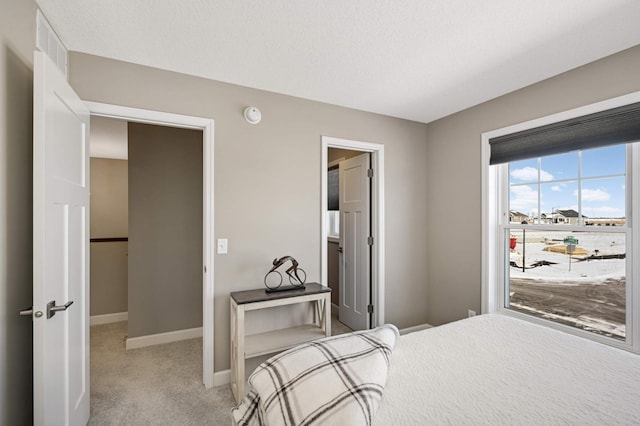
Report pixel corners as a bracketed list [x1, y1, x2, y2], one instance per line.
[483, 93, 640, 352]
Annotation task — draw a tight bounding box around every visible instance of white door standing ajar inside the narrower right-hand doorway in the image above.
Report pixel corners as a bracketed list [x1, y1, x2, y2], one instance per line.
[338, 153, 371, 330]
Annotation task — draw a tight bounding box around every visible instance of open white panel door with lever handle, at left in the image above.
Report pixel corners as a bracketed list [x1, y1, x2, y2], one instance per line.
[33, 52, 89, 425]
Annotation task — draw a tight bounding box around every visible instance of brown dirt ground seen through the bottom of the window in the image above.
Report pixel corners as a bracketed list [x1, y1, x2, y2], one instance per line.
[510, 277, 625, 338]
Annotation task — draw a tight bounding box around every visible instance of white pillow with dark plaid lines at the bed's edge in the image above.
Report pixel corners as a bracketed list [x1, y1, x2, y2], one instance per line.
[233, 325, 398, 426]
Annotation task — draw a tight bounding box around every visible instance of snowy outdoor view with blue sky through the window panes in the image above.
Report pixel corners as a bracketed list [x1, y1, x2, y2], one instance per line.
[503, 145, 631, 340]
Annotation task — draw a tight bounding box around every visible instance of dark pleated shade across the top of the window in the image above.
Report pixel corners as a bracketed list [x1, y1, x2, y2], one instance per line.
[489, 102, 640, 164]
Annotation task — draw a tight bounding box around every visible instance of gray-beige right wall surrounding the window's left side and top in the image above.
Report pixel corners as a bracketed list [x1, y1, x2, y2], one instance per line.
[425, 46, 640, 325]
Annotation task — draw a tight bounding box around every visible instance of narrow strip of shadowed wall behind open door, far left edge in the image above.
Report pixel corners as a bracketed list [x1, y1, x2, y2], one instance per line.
[0, 0, 36, 425]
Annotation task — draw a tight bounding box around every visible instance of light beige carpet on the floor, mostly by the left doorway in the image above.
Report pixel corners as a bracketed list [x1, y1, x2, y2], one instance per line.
[88, 315, 351, 426]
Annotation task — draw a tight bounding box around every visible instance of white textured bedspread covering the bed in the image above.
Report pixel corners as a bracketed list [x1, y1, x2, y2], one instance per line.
[374, 315, 640, 426]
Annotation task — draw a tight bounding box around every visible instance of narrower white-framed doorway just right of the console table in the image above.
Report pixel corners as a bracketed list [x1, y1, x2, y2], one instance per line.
[320, 136, 385, 330]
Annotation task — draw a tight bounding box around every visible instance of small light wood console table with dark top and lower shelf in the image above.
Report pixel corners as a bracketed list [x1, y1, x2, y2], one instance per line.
[231, 283, 331, 403]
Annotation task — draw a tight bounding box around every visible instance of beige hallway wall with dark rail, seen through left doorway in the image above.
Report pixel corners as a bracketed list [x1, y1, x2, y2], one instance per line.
[90, 158, 129, 315]
